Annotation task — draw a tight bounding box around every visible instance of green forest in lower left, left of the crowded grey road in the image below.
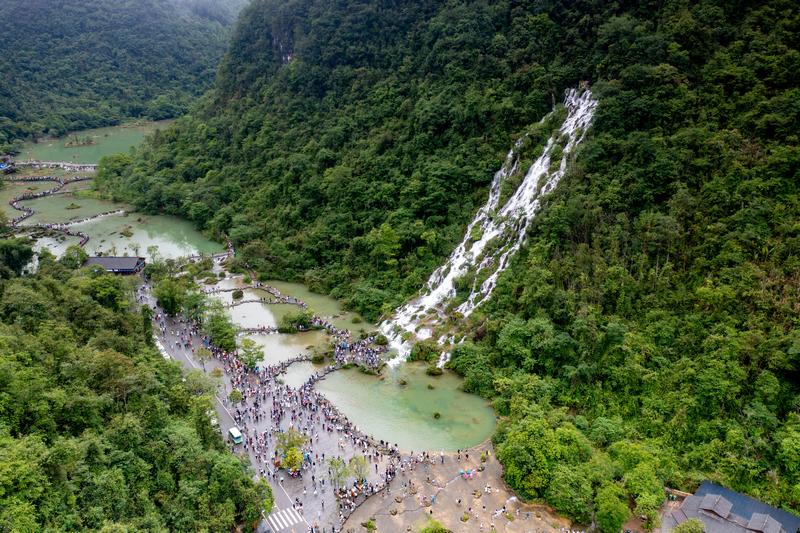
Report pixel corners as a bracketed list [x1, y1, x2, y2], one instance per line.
[0, 239, 272, 532]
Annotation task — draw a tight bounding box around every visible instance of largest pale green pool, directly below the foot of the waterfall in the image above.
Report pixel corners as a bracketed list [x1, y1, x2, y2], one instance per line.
[317, 363, 495, 451]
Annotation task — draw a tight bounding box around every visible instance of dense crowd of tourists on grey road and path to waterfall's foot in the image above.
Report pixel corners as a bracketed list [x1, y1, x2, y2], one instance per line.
[138, 276, 428, 532]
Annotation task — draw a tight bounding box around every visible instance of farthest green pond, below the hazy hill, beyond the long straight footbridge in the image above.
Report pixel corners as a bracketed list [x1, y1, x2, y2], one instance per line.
[17, 120, 171, 163]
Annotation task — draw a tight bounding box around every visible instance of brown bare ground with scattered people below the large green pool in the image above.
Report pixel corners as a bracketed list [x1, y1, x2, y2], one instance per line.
[344, 442, 571, 533]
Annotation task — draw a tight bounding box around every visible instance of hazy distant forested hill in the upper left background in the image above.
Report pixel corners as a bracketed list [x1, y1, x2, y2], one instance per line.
[0, 0, 244, 151]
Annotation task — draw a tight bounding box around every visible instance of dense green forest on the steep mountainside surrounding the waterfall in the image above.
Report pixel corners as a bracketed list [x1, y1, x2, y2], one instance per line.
[99, 0, 800, 532]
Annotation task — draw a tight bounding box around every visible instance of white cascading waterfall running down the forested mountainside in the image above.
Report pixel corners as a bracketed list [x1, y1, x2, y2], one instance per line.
[380, 89, 597, 366]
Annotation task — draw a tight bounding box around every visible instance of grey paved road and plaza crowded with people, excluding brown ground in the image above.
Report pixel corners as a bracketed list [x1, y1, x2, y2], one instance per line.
[139, 276, 400, 532]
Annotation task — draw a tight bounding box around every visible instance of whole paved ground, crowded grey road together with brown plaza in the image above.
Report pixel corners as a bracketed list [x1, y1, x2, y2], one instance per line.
[140, 262, 569, 533]
